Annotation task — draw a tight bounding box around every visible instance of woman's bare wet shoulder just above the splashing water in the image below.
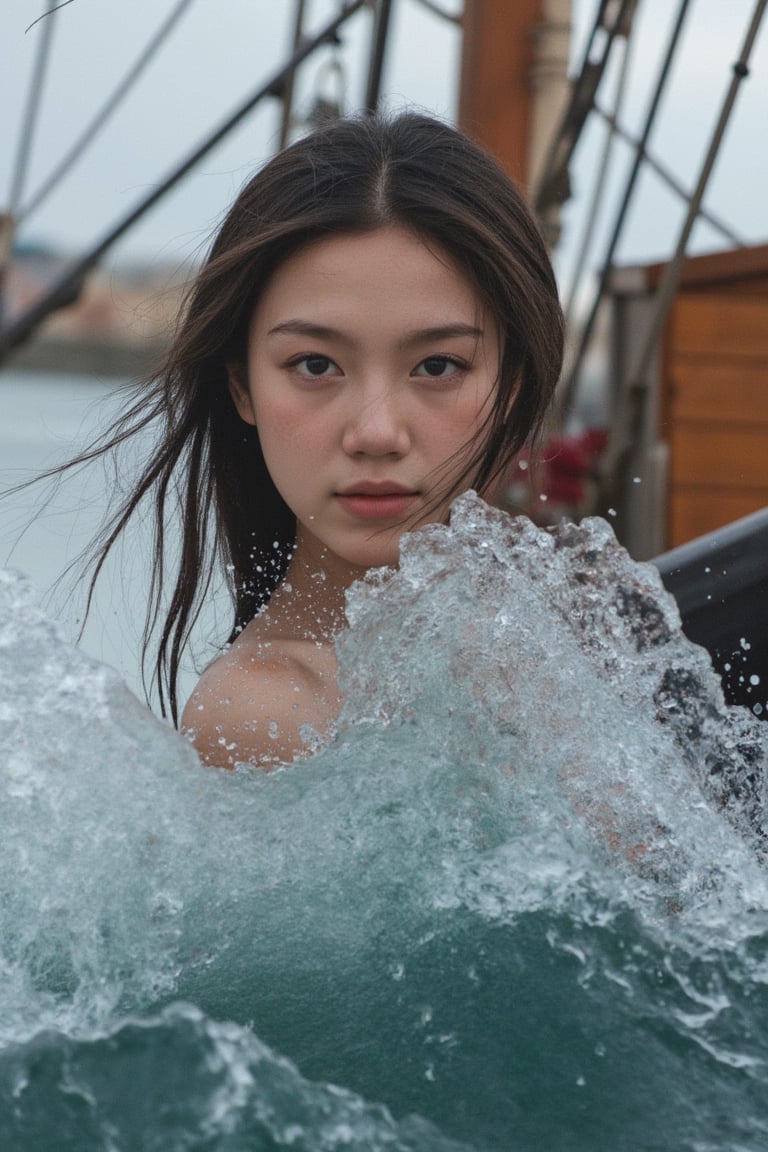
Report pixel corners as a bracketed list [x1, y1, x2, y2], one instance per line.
[182, 629, 339, 768]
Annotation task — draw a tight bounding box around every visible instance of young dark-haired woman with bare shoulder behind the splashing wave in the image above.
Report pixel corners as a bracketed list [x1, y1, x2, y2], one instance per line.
[74, 114, 563, 766]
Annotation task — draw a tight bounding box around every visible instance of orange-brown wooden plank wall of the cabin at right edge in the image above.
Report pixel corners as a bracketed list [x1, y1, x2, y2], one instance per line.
[660, 290, 768, 547]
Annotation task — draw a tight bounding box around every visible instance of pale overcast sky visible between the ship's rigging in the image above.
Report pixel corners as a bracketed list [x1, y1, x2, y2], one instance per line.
[0, 0, 768, 283]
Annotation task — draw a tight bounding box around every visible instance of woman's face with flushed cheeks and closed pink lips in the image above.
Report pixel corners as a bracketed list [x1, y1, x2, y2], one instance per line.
[230, 228, 501, 569]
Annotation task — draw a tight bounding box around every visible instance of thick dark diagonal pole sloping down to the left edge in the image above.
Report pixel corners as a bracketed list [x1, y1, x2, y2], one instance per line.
[0, 0, 367, 363]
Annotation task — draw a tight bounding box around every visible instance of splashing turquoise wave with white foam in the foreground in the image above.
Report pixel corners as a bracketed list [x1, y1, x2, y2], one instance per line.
[0, 495, 768, 1152]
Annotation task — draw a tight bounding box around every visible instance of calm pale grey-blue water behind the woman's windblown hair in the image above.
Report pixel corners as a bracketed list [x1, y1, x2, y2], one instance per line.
[0, 370, 223, 697]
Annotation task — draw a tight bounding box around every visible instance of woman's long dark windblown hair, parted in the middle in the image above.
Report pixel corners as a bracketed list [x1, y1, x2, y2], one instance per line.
[68, 113, 563, 722]
